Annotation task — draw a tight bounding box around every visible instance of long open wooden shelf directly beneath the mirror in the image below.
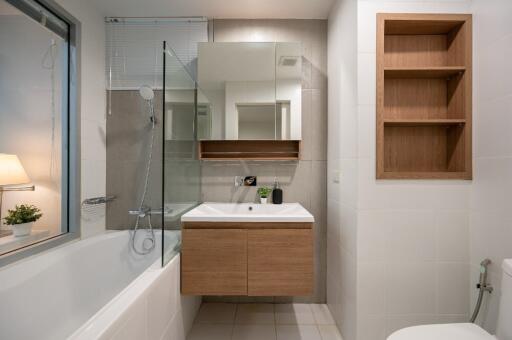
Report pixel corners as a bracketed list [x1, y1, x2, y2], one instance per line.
[199, 140, 300, 161]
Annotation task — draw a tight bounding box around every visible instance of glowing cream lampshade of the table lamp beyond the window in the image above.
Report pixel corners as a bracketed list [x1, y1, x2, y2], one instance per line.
[0, 153, 35, 227]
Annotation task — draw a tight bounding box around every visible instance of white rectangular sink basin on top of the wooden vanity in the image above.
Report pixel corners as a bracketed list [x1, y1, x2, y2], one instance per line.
[181, 203, 315, 222]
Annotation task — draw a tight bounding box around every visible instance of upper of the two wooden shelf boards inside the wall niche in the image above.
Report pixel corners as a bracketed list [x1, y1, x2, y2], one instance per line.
[384, 66, 466, 78]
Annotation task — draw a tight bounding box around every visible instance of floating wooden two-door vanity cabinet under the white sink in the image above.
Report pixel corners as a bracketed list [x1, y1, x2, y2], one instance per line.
[181, 222, 314, 296]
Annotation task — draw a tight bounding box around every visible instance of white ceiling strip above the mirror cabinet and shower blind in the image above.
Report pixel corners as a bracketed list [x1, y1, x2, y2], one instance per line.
[92, 0, 335, 19]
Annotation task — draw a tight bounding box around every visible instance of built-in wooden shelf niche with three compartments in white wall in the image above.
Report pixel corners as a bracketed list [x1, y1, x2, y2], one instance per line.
[377, 13, 472, 179]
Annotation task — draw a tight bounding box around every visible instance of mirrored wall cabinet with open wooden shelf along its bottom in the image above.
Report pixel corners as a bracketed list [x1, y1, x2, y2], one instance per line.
[197, 42, 302, 160]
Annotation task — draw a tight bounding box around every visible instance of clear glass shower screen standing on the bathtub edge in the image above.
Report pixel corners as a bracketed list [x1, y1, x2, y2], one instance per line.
[162, 42, 205, 265]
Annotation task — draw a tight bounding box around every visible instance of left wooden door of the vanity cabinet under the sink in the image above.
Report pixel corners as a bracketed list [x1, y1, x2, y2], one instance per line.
[181, 229, 247, 295]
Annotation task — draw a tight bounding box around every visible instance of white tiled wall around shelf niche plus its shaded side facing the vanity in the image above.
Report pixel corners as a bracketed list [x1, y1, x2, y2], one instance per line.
[327, 0, 471, 340]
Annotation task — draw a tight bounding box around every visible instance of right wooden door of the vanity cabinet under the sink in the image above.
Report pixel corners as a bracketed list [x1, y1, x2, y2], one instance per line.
[247, 229, 313, 296]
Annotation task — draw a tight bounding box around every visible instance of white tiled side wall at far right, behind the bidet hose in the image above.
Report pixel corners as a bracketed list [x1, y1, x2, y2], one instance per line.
[470, 0, 512, 332]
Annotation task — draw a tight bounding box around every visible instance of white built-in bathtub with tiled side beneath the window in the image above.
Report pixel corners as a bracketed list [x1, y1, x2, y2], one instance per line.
[0, 231, 200, 340]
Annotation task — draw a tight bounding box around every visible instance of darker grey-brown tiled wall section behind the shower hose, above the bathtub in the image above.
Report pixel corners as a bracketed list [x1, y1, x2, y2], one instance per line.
[106, 90, 163, 229]
